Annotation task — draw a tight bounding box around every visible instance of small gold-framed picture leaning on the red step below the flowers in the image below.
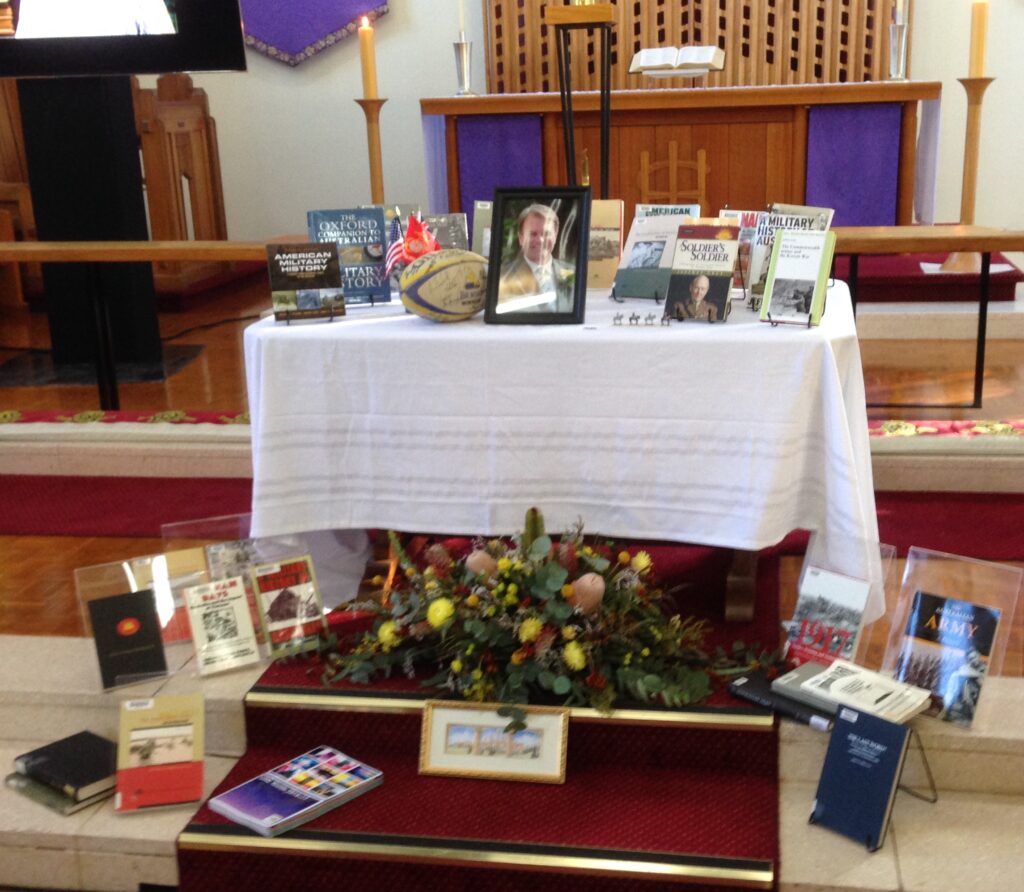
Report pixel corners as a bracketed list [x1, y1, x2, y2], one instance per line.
[420, 700, 569, 783]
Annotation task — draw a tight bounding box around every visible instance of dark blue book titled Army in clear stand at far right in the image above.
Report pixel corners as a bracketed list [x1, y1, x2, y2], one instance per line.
[895, 591, 1000, 727]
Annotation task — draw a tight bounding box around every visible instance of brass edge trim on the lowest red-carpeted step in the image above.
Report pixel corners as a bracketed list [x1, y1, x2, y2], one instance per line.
[178, 831, 775, 889]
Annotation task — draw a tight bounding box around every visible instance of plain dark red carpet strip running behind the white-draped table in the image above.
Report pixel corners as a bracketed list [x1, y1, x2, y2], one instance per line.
[0, 474, 1024, 560]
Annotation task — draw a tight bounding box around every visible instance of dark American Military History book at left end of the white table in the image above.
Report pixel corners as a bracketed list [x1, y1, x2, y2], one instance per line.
[266, 242, 345, 322]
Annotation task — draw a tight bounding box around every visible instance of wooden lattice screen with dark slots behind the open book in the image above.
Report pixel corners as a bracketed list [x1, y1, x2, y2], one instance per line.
[482, 0, 912, 93]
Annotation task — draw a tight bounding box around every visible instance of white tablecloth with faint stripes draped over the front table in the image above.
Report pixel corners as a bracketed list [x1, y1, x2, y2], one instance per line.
[245, 283, 883, 619]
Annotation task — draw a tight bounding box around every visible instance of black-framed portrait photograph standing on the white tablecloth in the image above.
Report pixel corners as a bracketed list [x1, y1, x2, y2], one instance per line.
[483, 186, 590, 325]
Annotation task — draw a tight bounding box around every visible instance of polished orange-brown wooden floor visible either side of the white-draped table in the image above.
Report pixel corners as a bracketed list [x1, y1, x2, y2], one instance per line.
[0, 274, 1024, 665]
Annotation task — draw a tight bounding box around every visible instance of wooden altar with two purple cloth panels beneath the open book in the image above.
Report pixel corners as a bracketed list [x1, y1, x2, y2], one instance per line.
[420, 82, 941, 225]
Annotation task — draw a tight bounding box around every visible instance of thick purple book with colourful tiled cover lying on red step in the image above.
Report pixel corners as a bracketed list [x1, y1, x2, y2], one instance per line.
[209, 746, 384, 837]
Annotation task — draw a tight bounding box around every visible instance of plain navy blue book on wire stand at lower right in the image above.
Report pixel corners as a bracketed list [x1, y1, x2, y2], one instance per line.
[810, 707, 910, 852]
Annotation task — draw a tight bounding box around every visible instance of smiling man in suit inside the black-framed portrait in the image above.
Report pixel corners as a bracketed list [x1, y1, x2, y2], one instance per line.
[498, 204, 575, 312]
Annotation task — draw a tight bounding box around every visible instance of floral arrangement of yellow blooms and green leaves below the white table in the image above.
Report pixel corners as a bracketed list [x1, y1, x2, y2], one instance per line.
[325, 508, 745, 713]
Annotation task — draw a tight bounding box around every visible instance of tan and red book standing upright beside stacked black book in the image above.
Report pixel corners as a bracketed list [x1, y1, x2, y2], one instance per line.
[114, 693, 205, 811]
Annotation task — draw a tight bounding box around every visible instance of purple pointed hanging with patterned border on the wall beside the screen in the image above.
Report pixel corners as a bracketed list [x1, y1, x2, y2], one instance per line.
[241, 0, 388, 66]
